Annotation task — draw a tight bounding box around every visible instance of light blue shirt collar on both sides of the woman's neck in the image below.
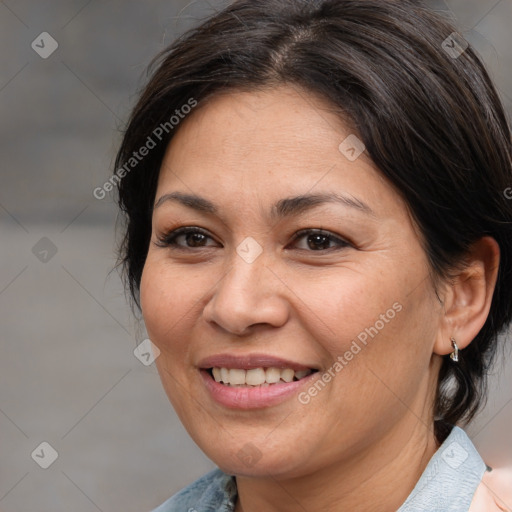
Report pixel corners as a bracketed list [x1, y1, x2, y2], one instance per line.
[153, 427, 486, 512]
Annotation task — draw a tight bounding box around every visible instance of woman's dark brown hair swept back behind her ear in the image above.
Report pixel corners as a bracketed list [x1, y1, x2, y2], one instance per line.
[116, 0, 512, 441]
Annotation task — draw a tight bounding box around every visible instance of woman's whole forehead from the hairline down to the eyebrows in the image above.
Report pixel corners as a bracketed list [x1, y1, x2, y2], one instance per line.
[157, 86, 400, 220]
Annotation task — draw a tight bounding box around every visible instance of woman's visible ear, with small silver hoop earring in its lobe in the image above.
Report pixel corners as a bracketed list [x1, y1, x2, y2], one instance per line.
[434, 236, 500, 355]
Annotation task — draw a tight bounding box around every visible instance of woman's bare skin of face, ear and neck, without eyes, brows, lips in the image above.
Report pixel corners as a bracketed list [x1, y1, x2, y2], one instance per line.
[141, 86, 499, 512]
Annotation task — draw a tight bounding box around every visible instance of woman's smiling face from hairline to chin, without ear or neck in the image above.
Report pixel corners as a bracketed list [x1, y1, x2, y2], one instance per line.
[141, 86, 441, 477]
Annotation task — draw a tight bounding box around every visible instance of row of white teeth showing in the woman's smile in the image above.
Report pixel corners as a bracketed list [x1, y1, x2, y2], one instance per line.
[207, 367, 317, 388]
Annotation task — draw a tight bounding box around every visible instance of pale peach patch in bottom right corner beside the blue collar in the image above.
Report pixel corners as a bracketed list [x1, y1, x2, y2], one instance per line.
[469, 468, 512, 512]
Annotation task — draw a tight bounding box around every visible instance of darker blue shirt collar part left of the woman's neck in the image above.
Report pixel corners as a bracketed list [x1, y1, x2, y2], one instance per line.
[149, 468, 236, 512]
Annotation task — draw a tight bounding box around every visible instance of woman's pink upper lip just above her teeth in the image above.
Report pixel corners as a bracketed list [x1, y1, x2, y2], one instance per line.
[197, 354, 315, 371]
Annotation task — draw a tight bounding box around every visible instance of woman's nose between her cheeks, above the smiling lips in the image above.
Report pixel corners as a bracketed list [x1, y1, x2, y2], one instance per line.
[203, 248, 289, 336]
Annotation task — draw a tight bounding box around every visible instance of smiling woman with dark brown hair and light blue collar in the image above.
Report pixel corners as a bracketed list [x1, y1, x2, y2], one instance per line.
[116, 0, 512, 512]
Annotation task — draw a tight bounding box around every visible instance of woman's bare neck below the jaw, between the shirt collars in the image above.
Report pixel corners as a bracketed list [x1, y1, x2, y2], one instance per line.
[235, 417, 437, 512]
